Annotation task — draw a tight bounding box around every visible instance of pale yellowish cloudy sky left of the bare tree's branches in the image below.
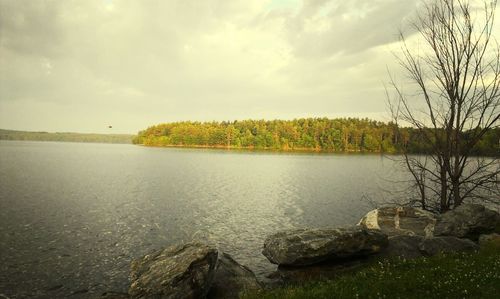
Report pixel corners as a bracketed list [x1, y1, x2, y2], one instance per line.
[0, 0, 492, 133]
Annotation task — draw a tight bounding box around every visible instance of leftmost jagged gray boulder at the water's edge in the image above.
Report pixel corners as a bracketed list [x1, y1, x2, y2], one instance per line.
[128, 243, 218, 299]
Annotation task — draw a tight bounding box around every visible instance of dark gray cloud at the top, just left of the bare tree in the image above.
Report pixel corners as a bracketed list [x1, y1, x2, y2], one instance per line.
[288, 0, 417, 58]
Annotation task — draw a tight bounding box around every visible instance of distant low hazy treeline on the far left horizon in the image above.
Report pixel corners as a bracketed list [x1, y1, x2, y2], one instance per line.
[0, 129, 134, 143]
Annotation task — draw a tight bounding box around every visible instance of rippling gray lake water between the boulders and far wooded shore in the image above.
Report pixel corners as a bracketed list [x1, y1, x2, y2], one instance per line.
[0, 141, 402, 298]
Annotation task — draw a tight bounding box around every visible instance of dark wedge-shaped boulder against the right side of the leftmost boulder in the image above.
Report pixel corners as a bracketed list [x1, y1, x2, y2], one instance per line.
[208, 253, 261, 299]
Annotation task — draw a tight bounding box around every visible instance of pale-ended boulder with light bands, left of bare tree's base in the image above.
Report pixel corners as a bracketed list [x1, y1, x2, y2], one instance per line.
[358, 207, 436, 237]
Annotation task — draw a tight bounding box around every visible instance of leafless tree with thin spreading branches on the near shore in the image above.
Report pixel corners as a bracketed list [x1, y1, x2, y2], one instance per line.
[390, 0, 500, 213]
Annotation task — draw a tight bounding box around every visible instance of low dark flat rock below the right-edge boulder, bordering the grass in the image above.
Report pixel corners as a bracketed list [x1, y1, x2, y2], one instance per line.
[419, 236, 479, 256]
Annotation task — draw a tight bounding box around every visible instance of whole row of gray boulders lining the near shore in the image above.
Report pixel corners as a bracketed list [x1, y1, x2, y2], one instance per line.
[100, 204, 500, 299]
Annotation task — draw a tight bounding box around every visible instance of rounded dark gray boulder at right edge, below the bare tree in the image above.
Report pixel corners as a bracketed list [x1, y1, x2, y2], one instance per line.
[434, 204, 500, 240]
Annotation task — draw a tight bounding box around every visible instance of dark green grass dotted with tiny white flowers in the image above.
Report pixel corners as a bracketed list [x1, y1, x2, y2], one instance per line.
[243, 244, 500, 299]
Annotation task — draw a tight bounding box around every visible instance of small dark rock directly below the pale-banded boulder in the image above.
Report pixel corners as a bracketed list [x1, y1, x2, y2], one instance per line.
[381, 235, 424, 259]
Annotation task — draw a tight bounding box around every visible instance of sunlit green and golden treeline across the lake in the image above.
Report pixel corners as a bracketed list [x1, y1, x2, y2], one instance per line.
[133, 118, 500, 155]
